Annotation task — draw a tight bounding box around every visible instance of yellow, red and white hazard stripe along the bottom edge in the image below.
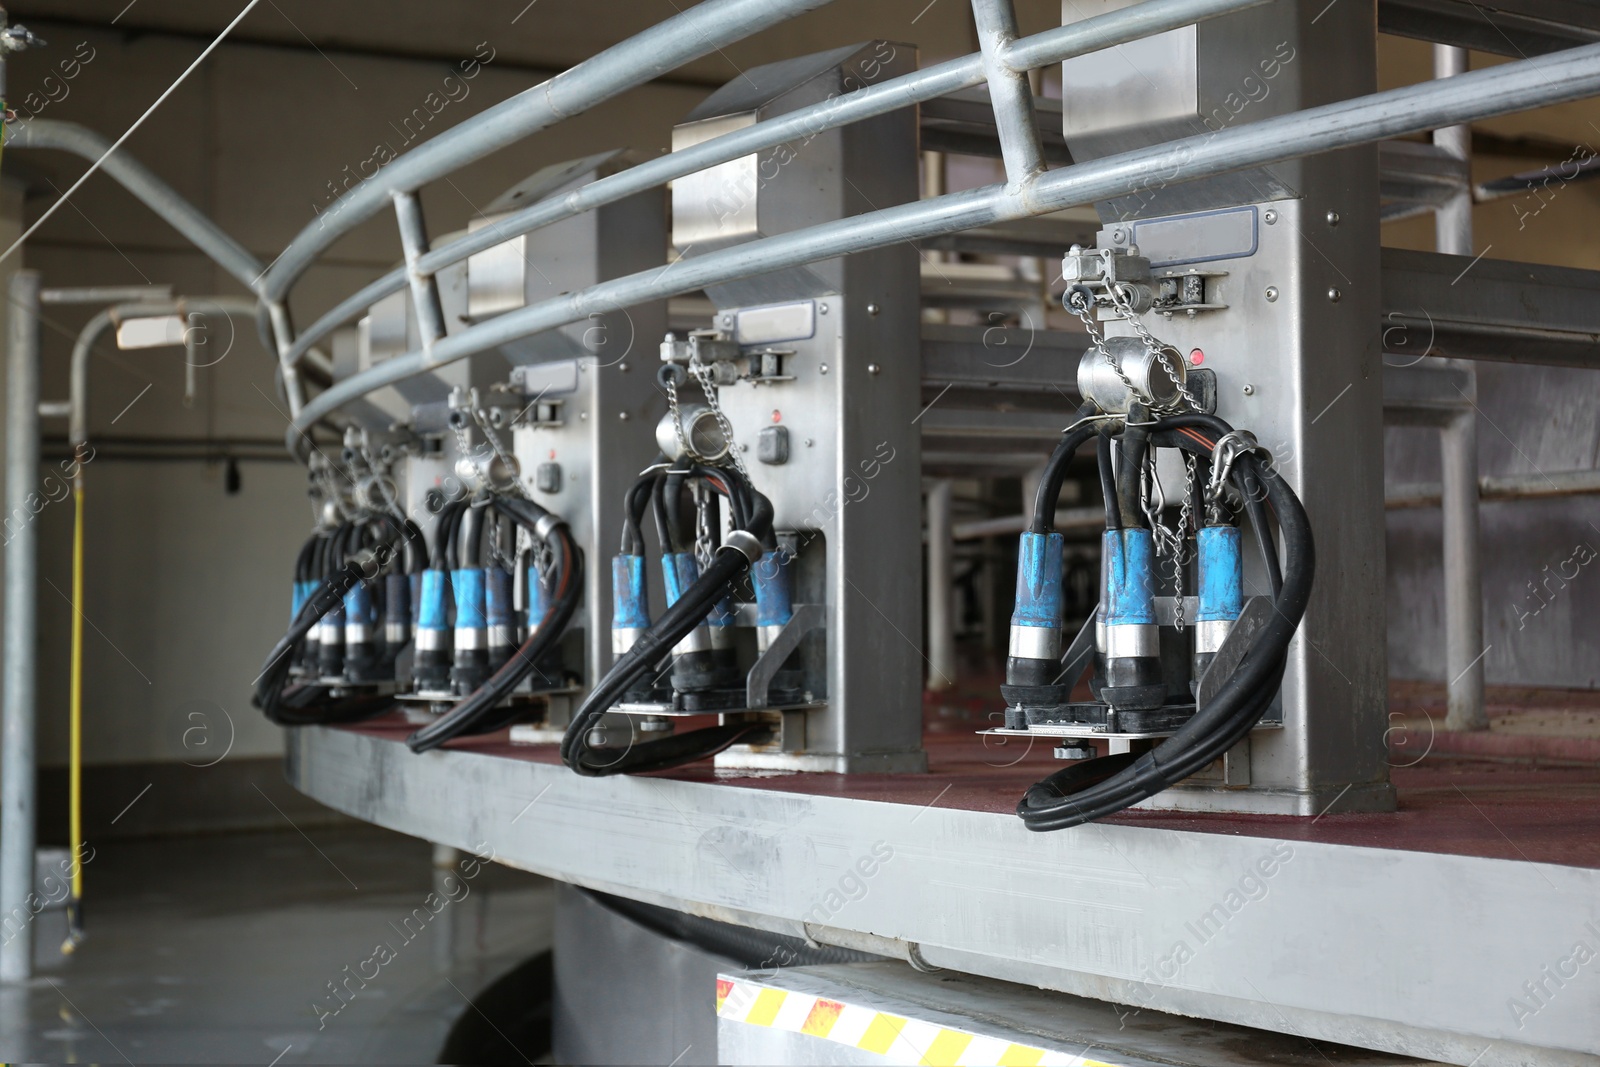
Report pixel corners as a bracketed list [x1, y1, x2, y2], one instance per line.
[717, 977, 1117, 1067]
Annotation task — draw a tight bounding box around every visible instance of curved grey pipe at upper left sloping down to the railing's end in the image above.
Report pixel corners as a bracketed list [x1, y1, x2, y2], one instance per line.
[5, 118, 266, 293]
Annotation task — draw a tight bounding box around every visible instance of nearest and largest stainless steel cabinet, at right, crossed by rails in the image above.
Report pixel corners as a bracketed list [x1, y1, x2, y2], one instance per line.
[1062, 3, 1395, 817]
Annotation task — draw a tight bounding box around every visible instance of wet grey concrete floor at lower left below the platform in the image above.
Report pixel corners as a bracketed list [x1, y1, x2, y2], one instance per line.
[0, 825, 554, 1064]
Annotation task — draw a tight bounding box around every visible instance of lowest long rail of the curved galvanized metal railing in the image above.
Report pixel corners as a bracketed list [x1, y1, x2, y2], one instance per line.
[286, 37, 1600, 454]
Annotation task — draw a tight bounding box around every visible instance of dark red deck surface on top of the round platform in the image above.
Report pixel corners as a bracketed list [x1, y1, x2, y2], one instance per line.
[337, 688, 1600, 869]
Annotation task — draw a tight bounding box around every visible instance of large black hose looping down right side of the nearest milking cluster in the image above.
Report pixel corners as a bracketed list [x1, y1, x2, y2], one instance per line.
[1018, 416, 1315, 830]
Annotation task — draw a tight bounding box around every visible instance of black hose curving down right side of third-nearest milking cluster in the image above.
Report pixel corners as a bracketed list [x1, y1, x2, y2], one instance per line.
[406, 498, 584, 752]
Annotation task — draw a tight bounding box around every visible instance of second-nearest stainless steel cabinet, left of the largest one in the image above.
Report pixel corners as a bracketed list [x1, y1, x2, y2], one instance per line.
[675, 42, 925, 771]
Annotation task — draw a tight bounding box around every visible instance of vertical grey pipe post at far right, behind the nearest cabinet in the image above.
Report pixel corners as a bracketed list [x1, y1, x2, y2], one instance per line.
[1434, 45, 1490, 729]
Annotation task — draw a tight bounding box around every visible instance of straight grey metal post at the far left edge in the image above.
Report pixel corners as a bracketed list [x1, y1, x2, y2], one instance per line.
[0, 270, 38, 982]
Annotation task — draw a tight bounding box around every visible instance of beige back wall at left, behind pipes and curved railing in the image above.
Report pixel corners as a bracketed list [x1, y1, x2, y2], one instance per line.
[3, 18, 704, 765]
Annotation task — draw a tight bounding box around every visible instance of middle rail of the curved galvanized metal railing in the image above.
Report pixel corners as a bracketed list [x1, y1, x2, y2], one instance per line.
[285, 0, 1269, 371]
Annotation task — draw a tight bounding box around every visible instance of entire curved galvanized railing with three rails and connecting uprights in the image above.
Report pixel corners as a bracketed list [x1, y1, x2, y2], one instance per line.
[256, 0, 1600, 454]
